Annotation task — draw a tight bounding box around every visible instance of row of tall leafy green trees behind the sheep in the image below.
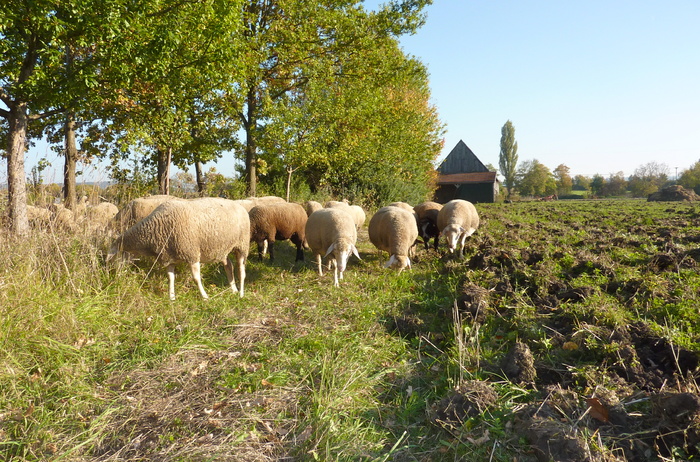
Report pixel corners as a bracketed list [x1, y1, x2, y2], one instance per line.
[0, 0, 443, 234]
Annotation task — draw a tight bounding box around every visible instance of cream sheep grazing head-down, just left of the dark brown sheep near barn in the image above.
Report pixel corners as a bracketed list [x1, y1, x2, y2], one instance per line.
[369, 206, 418, 272]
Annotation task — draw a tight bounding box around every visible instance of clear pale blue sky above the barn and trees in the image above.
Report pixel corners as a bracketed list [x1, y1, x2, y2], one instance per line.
[13, 0, 700, 182]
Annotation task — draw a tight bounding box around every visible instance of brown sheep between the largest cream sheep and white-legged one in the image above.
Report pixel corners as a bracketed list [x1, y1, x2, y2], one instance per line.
[248, 202, 308, 261]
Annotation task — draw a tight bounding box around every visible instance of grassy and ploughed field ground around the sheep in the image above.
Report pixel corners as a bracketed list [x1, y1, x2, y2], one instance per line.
[0, 200, 700, 462]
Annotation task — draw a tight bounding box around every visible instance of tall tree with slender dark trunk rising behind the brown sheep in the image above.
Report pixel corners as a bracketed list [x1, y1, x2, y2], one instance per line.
[225, 0, 429, 195]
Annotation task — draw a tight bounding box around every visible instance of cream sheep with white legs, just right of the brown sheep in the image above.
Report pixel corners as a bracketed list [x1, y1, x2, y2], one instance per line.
[306, 208, 361, 287]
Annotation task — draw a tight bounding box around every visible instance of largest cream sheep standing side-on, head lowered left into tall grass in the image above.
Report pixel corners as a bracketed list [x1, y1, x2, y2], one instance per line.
[107, 197, 250, 300]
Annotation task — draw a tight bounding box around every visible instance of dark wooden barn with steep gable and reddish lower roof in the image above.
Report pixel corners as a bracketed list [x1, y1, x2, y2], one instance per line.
[435, 140, 500, 204]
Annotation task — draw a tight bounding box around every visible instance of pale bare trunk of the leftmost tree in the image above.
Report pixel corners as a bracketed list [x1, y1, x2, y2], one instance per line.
[7, 102, 29, 236]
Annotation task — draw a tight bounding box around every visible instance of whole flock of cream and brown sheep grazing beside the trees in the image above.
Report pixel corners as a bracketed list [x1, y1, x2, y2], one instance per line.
[24, 196, 479, 300]
